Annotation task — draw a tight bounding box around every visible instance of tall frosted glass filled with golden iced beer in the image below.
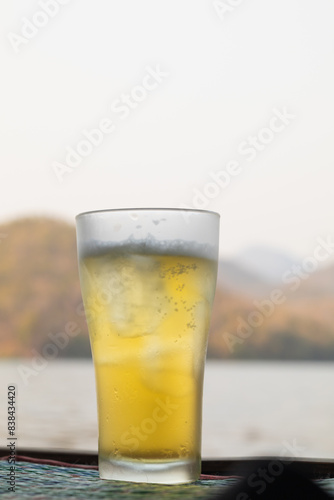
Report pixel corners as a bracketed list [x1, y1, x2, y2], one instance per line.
[76, 209, 219, 484]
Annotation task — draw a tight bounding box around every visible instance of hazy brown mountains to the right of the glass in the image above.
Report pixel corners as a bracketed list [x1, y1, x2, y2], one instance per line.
[208, 249, 334, 360]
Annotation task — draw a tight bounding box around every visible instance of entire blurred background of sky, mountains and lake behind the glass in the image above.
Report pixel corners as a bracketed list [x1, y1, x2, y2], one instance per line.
[0, 0, 334, 458]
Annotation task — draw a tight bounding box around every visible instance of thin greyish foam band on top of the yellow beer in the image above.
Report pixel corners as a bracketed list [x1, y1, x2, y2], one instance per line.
[79, 234, 217, 260]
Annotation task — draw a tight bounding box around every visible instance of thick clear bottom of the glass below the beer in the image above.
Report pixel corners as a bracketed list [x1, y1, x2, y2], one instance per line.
[99, 457, 201, 484]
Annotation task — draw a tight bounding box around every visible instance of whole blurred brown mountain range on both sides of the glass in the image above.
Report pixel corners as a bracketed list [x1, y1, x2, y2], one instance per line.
[0, 218, 334, 360]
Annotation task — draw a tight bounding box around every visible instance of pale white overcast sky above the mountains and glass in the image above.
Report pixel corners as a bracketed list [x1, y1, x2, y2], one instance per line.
[0, 0, 334, 257]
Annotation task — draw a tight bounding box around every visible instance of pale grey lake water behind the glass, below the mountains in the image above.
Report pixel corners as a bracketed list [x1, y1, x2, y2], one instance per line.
[0, 360, 334, 458]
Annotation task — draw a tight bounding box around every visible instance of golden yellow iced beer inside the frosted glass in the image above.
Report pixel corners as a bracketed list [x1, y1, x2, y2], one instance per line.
[80, 245, 216, 471]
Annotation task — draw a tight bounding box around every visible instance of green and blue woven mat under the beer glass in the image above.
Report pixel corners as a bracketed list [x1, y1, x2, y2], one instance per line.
[0, 460, 334, 500]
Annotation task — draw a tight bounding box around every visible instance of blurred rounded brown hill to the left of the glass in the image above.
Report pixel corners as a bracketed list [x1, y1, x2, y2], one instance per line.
[0, 218, 90, 356]
